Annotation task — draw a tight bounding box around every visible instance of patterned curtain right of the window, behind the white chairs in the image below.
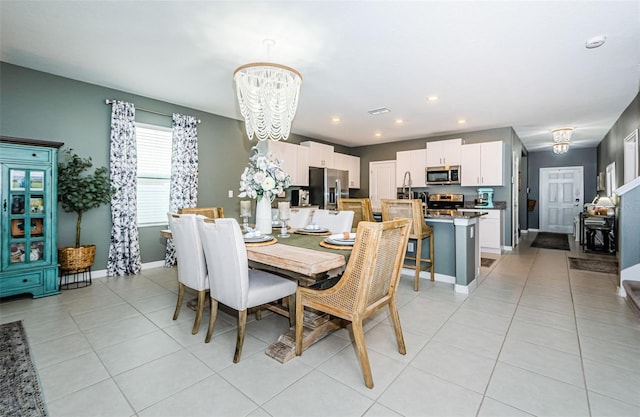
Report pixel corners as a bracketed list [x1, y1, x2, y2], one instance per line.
[164, 113, 198, 266]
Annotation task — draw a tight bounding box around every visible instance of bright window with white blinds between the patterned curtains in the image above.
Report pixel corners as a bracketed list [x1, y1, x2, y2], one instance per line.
[136, 123, 172, 226]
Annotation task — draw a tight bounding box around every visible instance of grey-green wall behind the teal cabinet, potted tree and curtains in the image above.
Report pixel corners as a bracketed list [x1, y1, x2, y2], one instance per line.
[0, 62, 320, 270]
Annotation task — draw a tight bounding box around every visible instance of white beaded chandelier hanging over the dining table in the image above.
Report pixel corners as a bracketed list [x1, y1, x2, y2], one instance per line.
[233, 62, 302, 141]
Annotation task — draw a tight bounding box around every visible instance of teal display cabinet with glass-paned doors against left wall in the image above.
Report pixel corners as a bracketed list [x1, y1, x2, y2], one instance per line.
[0, 137, 62, 298]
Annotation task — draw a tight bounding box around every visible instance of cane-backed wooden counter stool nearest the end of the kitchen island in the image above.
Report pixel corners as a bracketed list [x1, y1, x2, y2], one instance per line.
[381, 199, 435, 291]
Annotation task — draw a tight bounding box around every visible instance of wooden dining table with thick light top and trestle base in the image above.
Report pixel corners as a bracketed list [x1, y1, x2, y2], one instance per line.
[160, 224, 352, 363]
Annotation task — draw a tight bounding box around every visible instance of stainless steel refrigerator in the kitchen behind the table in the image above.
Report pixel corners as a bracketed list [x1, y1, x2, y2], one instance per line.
[309, 168, 349, 210]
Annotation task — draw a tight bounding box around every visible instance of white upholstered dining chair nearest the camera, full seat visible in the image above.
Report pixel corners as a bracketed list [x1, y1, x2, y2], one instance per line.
[198, 218, 298, 363]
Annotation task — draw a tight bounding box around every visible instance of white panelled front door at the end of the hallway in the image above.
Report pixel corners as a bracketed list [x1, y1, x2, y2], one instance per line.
[540, 167, 584, 233]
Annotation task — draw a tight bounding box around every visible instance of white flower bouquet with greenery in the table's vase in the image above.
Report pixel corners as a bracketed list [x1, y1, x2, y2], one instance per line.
[238, 146, 291, 201]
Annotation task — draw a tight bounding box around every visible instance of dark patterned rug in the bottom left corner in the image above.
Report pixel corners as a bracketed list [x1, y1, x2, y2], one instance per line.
[0, 321, 47, 417]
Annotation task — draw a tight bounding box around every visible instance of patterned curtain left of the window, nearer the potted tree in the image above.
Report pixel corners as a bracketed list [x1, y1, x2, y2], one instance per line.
[107, 101, 140, 276]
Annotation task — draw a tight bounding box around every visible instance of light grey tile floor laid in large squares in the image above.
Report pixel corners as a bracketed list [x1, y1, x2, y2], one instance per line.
[0, 233, 640, 417]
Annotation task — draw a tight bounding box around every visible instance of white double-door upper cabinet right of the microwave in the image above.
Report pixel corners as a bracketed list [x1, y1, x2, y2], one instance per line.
[460, 141, 504, 187]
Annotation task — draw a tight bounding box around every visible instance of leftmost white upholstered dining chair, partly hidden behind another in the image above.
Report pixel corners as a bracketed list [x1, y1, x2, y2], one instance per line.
[167, 213, 209, 334]
